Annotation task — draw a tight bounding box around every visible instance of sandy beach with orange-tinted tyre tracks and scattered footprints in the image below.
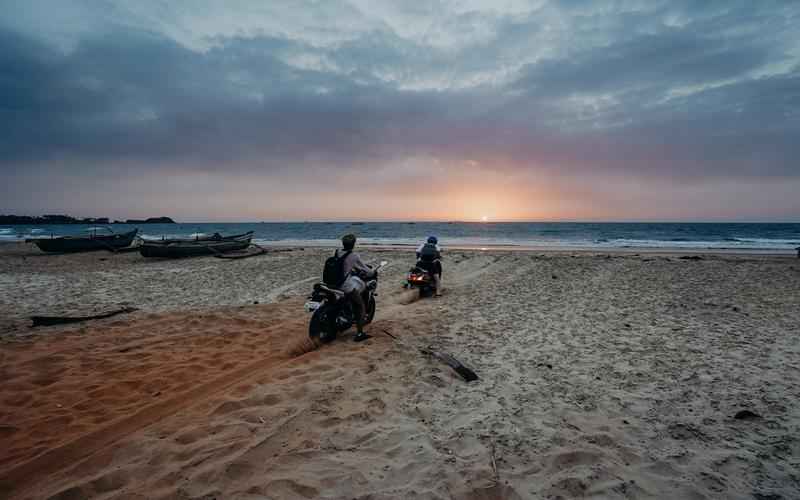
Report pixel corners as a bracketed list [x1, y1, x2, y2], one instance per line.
[0, 240, 800, 500]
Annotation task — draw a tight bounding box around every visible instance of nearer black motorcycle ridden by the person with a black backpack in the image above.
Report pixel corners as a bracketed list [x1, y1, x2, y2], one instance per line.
[305, 260, 389, 342]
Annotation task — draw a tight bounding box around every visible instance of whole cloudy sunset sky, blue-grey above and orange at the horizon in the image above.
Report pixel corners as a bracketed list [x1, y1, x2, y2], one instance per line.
[0, 0, 800, 221]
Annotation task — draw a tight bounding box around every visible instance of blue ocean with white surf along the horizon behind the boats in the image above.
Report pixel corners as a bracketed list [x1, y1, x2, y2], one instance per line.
[0, 222, 800, 252]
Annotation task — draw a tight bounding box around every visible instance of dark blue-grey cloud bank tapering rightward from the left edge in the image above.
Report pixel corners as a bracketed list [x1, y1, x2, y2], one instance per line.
[0, 26, 462, 172]
